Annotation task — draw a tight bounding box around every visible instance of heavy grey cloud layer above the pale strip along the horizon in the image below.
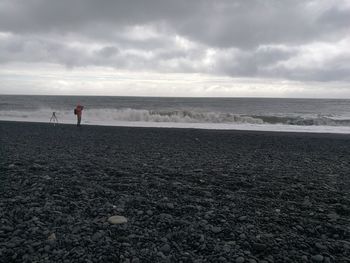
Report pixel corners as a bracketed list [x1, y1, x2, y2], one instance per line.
[0, 0, 350, 96]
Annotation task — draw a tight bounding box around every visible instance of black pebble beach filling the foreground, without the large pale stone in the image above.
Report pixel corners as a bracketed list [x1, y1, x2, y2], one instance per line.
[0, 122, 350, 263]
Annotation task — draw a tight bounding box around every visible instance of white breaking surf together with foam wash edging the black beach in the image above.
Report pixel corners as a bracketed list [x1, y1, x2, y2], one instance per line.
[0, 108, 350, 133]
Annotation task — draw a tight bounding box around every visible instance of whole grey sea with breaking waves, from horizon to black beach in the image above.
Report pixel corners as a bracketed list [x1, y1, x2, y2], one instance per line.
[0, 95, 350, 133]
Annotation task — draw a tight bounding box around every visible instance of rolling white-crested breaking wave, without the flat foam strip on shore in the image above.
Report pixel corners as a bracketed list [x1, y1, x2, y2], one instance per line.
[0, 108, 350, 127]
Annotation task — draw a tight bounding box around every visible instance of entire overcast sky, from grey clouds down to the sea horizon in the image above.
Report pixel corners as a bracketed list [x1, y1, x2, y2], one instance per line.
[0, 0, 350, 98]
